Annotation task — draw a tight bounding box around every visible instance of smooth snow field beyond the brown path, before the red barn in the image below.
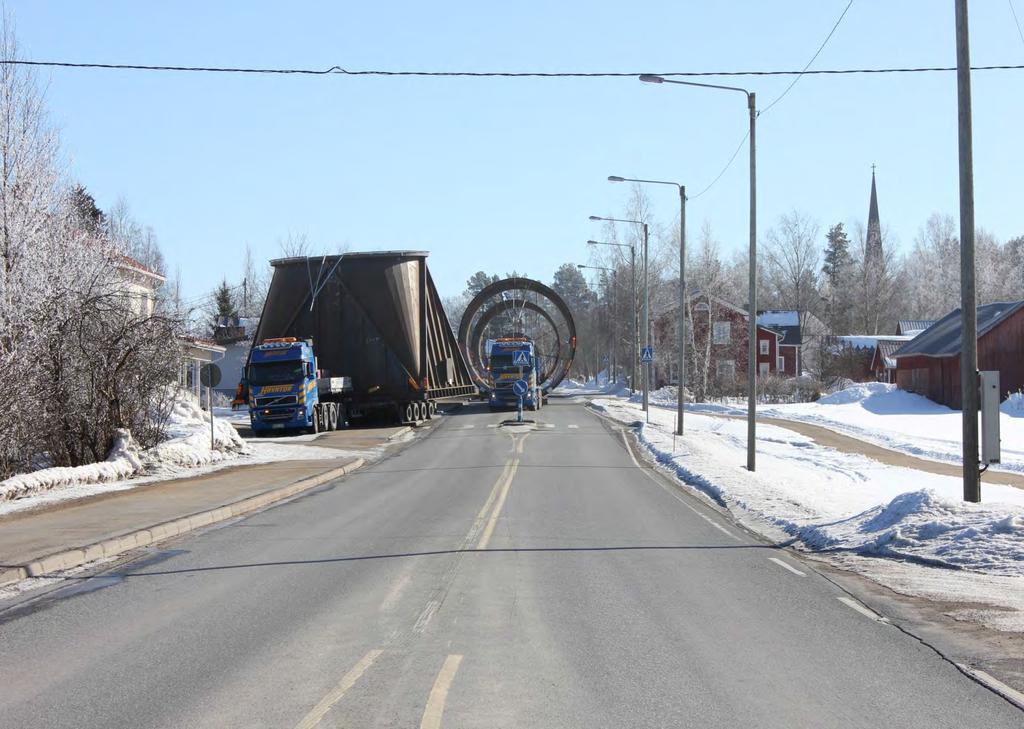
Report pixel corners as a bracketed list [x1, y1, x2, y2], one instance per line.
[679, 382, 1024, 473]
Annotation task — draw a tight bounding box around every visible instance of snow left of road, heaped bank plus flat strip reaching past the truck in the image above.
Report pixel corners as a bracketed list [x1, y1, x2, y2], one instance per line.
[0, 393, 369, 515]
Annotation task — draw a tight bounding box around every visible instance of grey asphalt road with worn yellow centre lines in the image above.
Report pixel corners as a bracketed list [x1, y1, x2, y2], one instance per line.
[0, 401, 1024, 729]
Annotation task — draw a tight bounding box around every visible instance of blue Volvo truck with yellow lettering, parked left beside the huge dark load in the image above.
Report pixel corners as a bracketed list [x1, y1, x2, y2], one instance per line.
[246, 337, 352, 434]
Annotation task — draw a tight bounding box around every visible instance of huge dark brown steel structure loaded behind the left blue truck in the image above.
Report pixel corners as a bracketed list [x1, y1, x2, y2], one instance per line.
[255, 251, 476, 422]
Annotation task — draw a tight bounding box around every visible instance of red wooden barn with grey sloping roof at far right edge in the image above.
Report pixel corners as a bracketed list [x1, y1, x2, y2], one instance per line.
[893, 301, 1024, 409]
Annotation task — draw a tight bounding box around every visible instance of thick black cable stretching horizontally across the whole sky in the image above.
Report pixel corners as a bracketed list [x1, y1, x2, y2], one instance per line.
[0, 59, 1024, 79]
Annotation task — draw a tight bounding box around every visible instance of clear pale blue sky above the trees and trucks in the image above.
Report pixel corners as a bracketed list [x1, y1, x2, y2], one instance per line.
[7, 0, 1024, 296]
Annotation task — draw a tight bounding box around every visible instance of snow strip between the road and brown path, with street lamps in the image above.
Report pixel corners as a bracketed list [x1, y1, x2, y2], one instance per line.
[593, 392, 1024, 632]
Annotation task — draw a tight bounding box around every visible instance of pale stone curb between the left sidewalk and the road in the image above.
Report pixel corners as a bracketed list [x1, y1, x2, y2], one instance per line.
[0, 458, 366, 586]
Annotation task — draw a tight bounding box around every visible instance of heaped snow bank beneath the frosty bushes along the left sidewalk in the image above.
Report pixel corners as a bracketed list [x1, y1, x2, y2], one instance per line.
[0, 392, 246, 502]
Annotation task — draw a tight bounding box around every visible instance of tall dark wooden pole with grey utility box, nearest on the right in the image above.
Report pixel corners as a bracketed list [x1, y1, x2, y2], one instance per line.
[954, 0, 981, 504]
